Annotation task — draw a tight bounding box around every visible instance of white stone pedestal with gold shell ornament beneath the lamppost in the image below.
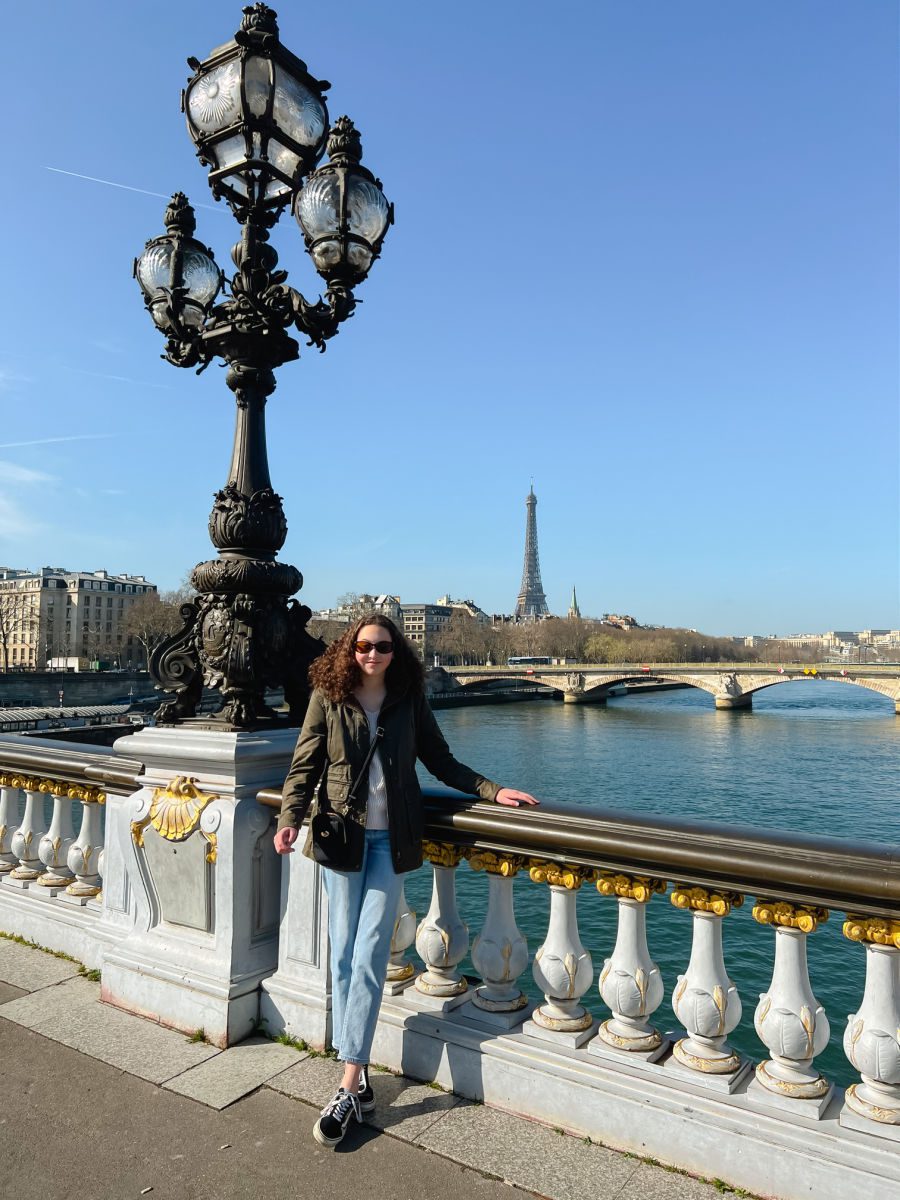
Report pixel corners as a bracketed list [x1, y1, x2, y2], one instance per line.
[102, 726, 296, 1046]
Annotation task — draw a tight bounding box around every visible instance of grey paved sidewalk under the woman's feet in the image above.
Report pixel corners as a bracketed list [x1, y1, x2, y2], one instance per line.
[0, 937, 748, 1200]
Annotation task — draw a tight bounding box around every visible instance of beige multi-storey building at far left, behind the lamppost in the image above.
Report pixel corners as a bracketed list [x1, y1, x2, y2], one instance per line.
[0, 566, 157, 671]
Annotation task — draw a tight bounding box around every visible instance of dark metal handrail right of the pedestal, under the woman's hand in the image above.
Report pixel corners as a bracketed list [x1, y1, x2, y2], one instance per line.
[257, 788, 900, 918]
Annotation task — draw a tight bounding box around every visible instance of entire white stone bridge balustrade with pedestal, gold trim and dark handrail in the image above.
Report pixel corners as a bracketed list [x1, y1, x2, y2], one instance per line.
[0, 727, 900, 1200]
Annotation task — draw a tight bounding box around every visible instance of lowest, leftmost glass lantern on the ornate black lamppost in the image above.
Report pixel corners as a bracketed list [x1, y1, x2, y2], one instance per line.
[134, 192, 222, 334]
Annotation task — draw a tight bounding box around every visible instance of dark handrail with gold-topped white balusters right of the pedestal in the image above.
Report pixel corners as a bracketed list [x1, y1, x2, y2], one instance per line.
[259, 791, 900, 1136]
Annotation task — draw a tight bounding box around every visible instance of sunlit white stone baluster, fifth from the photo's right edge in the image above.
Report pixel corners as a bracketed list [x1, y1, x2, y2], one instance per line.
[522, 862, 595, 1046]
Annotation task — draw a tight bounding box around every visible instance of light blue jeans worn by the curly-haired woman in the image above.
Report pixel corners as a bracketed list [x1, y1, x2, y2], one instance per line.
[325, 829, 403, 1063]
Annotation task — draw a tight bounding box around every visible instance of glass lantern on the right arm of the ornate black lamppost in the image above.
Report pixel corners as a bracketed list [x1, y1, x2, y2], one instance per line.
[294, 116, 394, 286]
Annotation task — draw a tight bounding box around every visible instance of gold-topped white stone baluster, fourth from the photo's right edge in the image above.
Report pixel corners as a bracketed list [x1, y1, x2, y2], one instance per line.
[590, 874, 668, 1062]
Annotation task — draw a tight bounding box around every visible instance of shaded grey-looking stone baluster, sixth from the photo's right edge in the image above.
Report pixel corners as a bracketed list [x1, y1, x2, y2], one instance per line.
[468, 851, 528, 1026]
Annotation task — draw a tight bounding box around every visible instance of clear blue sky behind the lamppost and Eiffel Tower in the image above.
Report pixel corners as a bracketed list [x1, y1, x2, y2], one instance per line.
[0, 0, 900, 634]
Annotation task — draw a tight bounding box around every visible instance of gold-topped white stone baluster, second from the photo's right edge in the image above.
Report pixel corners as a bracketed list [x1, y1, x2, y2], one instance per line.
[748, 899, 834, 1118]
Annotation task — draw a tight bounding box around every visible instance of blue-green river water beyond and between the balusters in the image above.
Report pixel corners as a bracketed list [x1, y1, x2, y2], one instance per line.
[407, 679, 900, 1085]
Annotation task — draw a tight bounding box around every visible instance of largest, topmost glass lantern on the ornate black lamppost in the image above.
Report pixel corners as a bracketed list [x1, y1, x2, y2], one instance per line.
[182, 4, 329, 209]
